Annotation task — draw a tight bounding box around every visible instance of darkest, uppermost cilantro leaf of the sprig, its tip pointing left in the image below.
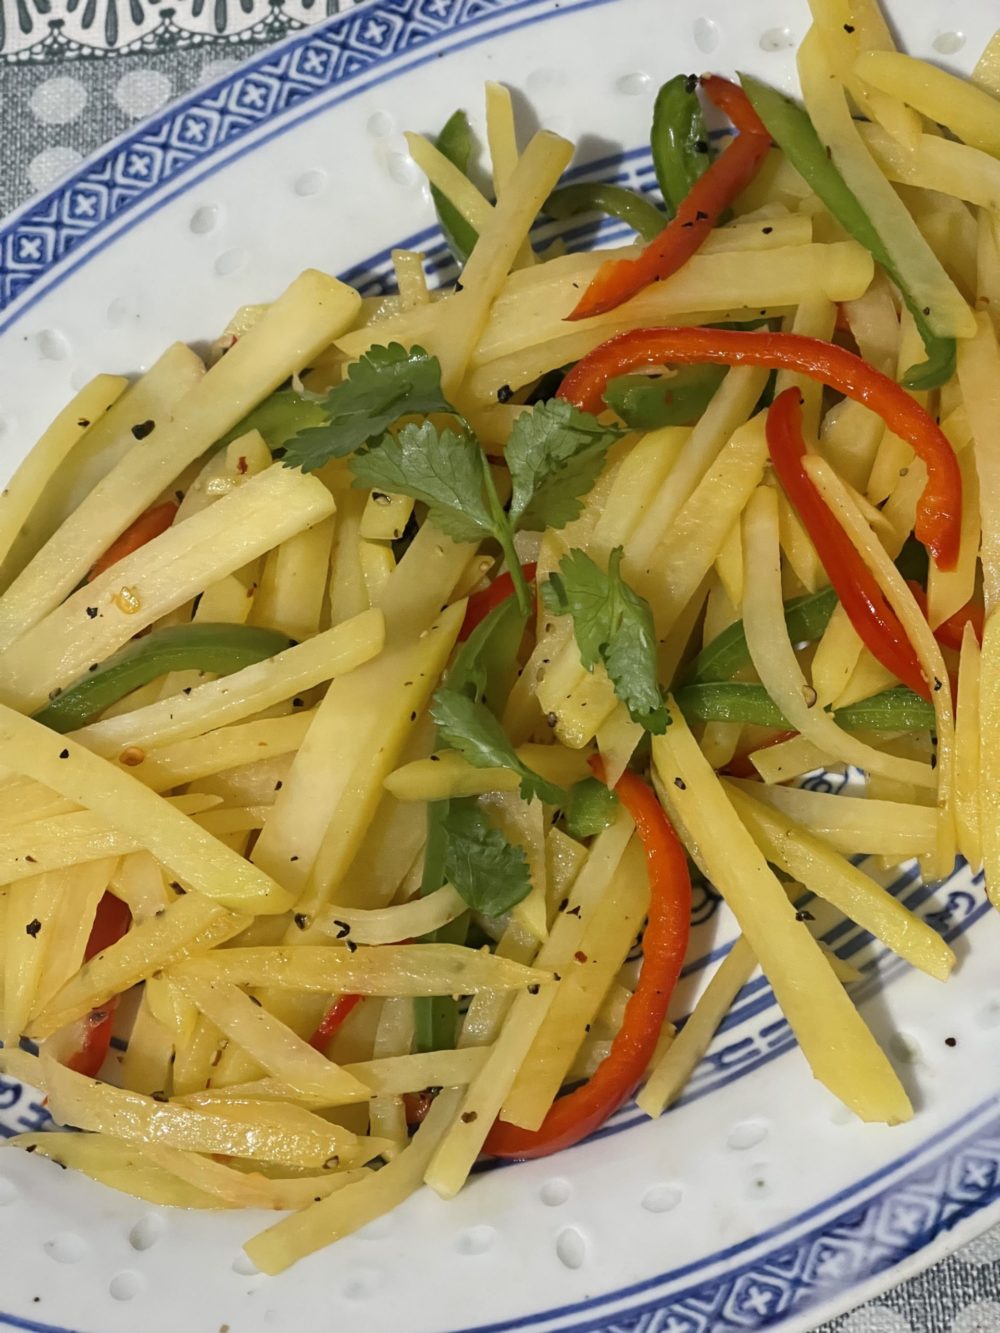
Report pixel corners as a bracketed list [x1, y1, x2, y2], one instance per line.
[283, 343, 455, 472]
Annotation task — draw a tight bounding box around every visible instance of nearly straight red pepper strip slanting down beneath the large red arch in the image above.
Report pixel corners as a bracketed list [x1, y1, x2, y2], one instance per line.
[767, 389, 931, 701]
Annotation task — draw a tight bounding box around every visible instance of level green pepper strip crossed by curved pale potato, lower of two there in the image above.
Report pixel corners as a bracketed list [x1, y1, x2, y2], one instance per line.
[675, 681, 935, 732]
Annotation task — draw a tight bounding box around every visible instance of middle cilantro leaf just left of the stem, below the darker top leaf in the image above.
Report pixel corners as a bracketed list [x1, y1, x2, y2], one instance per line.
[351, 421, 497, 541]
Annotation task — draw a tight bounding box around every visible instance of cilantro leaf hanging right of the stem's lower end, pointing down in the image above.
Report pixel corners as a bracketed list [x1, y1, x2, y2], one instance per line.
[543, 547, 668, 736]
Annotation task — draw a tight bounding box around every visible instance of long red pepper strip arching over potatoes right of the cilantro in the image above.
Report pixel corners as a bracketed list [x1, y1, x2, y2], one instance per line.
[557, 327, 961, 569]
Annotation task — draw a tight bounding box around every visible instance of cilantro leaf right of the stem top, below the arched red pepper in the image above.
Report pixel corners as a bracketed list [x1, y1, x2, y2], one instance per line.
[504, 399, 624, 532]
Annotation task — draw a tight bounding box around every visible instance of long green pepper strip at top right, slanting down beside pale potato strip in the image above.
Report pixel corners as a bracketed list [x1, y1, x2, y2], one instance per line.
[740, 75, 955, 389]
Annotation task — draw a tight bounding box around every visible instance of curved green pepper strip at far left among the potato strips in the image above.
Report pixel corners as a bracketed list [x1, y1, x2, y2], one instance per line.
[33, 624, 295, 732]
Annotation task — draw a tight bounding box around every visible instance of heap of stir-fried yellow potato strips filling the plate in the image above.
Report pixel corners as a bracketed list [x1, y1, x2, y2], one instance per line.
[0, 15, 1000, 1273]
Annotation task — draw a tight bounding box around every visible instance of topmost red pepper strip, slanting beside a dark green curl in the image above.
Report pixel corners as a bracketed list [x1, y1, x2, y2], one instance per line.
[568, 75, 771, 320]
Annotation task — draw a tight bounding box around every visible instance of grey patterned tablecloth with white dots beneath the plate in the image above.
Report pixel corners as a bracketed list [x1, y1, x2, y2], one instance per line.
[0, 0, 1000, 1333]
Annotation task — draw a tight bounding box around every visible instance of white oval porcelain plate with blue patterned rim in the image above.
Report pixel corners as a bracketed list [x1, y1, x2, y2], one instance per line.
[0, 0, 1000, 1333]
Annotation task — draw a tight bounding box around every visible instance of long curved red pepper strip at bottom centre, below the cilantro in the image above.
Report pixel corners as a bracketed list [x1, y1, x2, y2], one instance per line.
[484, 757, 691, 1160]
